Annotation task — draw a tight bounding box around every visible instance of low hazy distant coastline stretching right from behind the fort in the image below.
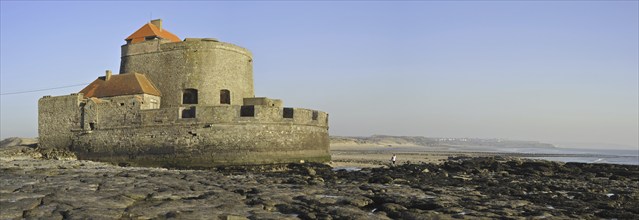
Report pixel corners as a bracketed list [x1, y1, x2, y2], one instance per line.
[331, 135, 555, 148]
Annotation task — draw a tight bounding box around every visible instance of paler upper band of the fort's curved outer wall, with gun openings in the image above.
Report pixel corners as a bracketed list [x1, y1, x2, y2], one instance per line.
[83, 102, 328, 130]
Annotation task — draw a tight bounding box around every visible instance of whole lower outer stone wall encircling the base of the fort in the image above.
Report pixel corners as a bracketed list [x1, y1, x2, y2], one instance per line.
[39, 94, 330, 168]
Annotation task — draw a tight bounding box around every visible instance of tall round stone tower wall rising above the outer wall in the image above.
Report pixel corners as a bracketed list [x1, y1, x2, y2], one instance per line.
[120, 39, 255, 108]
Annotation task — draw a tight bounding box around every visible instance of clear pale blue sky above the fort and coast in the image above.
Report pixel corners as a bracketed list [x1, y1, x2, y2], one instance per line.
[0, 1, 639, 149]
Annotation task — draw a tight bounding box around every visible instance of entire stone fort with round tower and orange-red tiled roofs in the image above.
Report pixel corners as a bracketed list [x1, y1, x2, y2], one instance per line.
[38, 20, 330, 168]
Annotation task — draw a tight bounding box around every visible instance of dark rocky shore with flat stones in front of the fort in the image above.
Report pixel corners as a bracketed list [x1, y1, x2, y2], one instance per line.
[0, 144, 639, 219]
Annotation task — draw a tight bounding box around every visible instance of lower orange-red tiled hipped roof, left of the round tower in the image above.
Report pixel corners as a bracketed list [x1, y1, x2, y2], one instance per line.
[80, 73, 161, 98]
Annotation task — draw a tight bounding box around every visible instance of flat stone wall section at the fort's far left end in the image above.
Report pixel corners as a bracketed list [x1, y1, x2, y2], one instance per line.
[38, 93, 83, 149]
